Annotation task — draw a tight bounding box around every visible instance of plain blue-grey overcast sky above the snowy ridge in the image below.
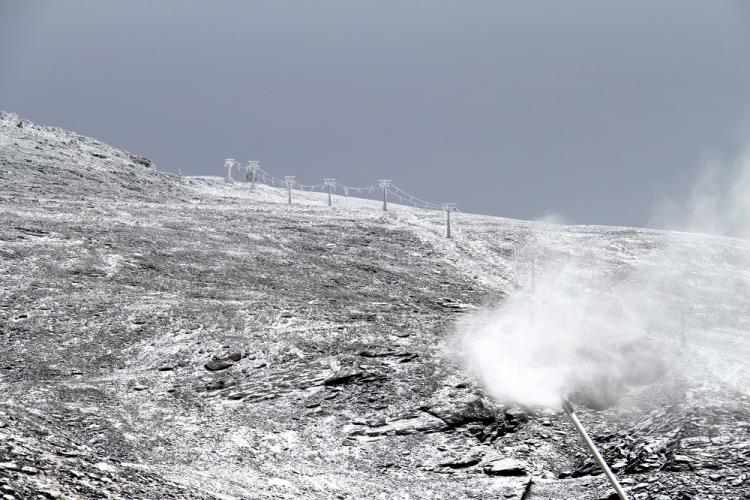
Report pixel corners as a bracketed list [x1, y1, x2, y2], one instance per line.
[0, 0, 750, 225]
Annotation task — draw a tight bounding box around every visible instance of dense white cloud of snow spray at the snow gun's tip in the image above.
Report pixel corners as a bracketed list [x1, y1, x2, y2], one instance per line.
[458, 254, 664, 407]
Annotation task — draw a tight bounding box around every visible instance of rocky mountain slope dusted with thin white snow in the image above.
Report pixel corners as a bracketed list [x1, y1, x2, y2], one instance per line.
[0, 113, 750, 499]
